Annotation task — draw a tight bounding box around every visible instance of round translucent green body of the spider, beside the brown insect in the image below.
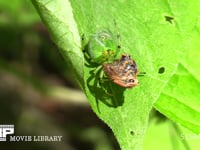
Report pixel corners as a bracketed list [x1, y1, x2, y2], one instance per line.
[83, 30, 120, 65]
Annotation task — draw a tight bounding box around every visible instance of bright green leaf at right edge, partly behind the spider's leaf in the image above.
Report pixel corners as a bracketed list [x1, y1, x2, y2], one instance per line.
[155, 17, 200, 133]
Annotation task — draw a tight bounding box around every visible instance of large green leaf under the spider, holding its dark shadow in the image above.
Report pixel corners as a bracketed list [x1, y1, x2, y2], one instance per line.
[71, 0, 183, 150]
